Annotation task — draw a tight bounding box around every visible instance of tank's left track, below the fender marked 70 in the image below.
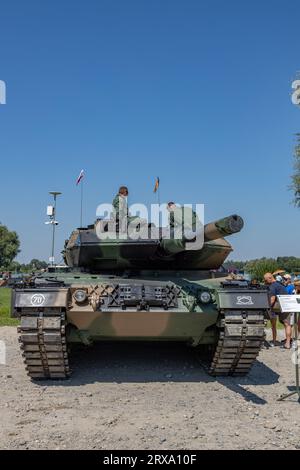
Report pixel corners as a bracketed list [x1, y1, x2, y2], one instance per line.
[18, 309, 71, 379]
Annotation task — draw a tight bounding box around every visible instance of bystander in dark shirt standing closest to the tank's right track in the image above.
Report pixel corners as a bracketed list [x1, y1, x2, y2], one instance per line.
[264, 273, 292, 349]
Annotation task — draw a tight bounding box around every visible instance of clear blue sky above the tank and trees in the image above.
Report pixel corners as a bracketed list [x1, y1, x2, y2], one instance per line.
[0, 0, 300, 261]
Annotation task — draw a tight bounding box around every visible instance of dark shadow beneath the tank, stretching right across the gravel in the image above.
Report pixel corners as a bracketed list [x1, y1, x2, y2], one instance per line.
[39, 342, 279, 404]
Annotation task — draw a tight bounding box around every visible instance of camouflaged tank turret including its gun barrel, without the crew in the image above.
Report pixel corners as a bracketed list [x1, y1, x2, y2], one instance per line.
[64, 215, 244, 272]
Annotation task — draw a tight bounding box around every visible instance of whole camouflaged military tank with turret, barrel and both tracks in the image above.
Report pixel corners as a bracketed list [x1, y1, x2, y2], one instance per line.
[12, 215, 269, 379]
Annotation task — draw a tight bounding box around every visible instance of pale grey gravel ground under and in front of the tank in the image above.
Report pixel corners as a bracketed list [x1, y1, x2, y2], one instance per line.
[0, 327, 300, 450]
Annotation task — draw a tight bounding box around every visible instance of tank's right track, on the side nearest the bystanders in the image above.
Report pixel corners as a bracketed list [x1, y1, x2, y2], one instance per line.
[208, 310, 265, 376]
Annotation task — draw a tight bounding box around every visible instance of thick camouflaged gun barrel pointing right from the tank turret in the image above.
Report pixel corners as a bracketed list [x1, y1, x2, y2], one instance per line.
[204, 214, 244, 241]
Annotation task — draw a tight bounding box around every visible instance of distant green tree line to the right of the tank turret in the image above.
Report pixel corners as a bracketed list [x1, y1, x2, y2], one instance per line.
[224, 256, 300, 280]
